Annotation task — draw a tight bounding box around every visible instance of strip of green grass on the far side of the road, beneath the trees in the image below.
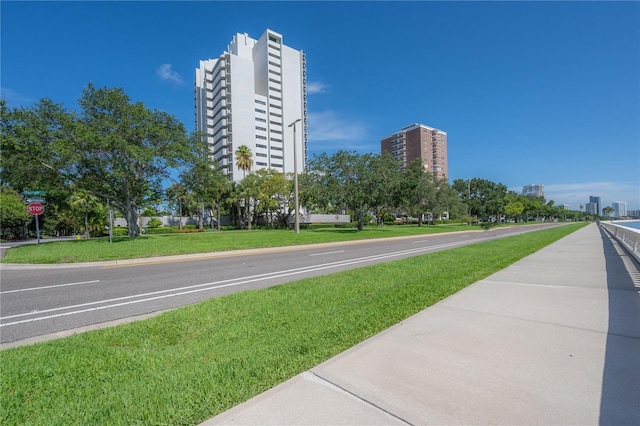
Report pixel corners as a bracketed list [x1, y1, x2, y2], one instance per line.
[2, 225, 480, 263]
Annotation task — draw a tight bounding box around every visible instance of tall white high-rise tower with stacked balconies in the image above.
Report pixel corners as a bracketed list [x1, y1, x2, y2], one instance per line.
[195, 29, 308, 181]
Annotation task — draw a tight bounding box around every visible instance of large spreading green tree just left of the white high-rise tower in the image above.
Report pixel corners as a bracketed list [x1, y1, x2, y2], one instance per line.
[71, 84, 193, 237]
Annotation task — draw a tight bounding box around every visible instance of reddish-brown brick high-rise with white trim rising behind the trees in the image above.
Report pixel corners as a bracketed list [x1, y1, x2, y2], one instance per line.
[380, 123, 449, 179]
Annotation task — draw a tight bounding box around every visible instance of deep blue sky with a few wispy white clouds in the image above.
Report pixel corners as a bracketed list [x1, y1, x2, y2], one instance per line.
[0, 0, 640, 210]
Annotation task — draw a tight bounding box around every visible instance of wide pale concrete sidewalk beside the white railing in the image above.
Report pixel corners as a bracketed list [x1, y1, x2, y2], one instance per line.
[204, 224, 640, 425]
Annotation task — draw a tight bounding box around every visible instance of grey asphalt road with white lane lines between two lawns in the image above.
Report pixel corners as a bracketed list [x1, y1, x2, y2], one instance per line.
[0, 224, 556, 348]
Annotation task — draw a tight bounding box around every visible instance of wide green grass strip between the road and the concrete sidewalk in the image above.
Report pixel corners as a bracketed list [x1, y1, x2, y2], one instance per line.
[0, 224, 585, 425]
